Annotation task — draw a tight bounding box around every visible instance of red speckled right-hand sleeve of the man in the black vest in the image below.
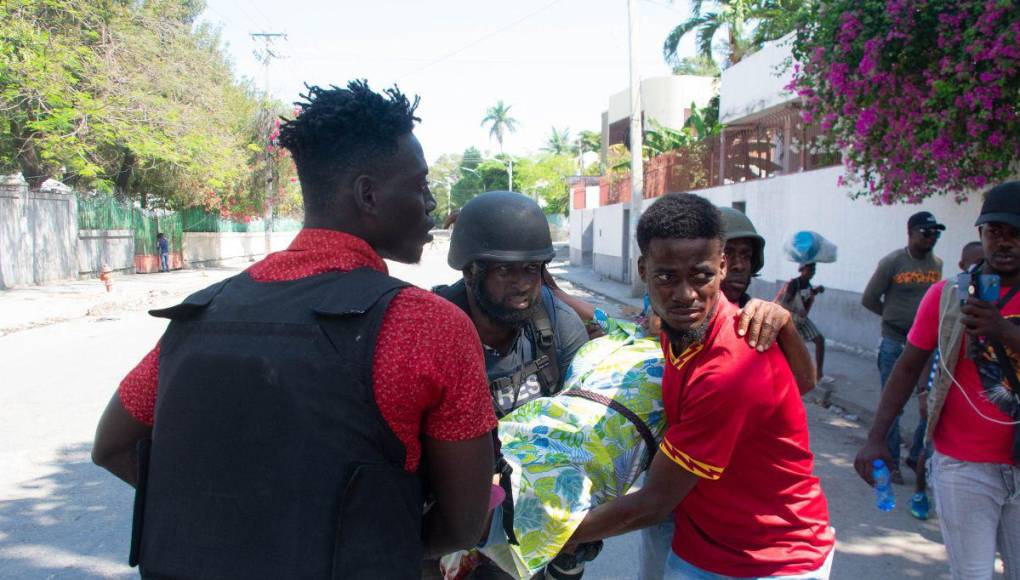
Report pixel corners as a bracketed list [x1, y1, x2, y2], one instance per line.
[373, 288, 497, 471]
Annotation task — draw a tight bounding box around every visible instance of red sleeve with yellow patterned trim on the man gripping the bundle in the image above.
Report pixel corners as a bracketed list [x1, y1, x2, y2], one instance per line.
[659, 361, 773, 479]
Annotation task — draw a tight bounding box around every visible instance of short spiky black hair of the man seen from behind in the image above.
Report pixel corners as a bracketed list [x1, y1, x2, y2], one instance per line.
[279, 80, 421, 209]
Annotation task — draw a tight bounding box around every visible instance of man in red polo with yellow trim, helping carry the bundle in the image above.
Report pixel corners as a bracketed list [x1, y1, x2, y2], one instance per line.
[571, 194, 835, 580]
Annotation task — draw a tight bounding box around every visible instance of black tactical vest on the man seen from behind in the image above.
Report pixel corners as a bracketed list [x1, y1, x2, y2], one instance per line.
[133, 269, 423, 580]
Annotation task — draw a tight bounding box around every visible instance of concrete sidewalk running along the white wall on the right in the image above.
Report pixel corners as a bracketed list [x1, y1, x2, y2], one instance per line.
[549, 260, 920, 466]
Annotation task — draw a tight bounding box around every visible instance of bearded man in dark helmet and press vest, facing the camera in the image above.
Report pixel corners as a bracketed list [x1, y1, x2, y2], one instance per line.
[423, 192, 588, 578]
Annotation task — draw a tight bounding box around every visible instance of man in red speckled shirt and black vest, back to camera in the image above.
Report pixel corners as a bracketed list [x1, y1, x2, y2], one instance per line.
[93, 82, 496, 578]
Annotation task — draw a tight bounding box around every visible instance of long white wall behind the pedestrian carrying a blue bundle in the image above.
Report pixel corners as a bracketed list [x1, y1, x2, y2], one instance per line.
[697, 167, 981, 350]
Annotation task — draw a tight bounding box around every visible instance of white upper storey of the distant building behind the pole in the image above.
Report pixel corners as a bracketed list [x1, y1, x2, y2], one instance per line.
[608, 74, 718, 130]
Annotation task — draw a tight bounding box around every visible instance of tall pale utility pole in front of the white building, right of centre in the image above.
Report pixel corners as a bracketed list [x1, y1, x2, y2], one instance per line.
[627, 0, 645, 298]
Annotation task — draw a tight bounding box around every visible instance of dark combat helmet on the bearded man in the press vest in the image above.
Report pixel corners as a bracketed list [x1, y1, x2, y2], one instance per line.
[447, 192, 556, 270]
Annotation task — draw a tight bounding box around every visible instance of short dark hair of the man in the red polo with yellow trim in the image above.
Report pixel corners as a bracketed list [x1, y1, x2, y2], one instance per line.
[638, 194, 726, 254]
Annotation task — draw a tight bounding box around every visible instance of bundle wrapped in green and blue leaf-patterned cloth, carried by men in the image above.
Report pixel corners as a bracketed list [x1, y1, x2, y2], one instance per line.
[444, 311, 666, 578]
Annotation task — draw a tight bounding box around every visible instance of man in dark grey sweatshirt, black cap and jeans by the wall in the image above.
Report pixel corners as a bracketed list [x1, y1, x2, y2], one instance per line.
[861, 211, 946, 485]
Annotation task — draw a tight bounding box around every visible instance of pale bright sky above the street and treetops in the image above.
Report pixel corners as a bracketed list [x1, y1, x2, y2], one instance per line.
[196, 0, 694, 160]
